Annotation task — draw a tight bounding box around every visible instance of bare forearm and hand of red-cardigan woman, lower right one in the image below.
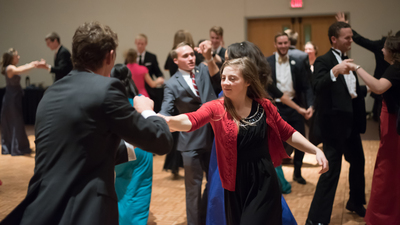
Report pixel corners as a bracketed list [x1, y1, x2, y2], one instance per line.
[286, 131, 329, 174]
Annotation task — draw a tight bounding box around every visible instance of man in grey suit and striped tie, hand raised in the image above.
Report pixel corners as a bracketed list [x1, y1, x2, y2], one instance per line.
[160, 42, 221, 225]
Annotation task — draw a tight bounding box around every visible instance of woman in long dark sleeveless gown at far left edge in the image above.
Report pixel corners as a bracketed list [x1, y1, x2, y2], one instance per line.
[1, 48, 42, 156]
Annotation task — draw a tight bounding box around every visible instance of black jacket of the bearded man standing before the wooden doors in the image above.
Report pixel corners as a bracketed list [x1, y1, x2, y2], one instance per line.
[267, 54, 314, 109]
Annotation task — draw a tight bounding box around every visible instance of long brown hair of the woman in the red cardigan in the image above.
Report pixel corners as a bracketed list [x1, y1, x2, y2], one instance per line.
[221, 57, 267, 123]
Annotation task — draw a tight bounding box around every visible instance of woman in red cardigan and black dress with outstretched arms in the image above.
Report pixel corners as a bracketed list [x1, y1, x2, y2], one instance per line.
[156, 57, 328, 224]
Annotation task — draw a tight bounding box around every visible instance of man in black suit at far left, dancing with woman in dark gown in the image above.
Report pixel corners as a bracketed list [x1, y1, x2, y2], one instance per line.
[39, 32, 72, 82]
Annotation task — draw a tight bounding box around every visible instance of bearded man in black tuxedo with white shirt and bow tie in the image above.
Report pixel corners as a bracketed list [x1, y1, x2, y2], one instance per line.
[267, 33, 313, 184]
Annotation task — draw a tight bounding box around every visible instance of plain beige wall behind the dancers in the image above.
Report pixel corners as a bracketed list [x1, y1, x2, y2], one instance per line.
[0, 0, 400, 108]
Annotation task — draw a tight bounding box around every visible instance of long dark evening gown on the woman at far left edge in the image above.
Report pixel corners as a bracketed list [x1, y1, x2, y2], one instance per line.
[1, 75, 32, 156]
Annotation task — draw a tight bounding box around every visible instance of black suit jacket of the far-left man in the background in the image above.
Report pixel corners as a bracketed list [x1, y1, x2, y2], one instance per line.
[50, 45, 72, 81]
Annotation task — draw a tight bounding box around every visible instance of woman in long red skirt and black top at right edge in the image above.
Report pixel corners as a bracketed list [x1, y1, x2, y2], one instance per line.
[349, 32, 400, 225]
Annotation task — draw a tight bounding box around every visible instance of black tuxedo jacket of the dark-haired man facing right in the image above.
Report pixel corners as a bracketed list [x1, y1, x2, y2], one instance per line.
[313, 50, 367, 139]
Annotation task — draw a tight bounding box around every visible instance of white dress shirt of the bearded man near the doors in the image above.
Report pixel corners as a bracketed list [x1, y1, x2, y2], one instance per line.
[275, 53, 296, 102]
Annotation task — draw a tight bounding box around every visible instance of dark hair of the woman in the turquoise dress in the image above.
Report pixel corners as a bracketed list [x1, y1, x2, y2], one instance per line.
[111, 64, 139, 98]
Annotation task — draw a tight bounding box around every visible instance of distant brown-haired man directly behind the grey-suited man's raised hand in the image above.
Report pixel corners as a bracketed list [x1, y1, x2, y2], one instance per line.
[210, 26, 226, 68]
